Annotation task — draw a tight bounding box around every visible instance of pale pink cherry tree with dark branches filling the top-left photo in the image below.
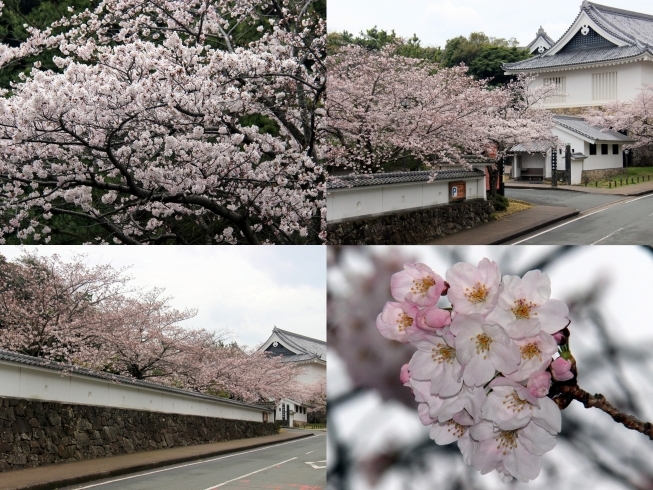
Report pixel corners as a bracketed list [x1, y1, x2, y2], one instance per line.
[0, 0, 326, 244]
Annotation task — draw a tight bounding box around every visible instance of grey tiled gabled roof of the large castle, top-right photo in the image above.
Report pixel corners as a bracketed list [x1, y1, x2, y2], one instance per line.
[503, 0, 653, 73]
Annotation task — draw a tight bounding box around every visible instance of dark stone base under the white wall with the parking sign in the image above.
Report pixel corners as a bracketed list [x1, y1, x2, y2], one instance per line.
[327, 200, 494, 245]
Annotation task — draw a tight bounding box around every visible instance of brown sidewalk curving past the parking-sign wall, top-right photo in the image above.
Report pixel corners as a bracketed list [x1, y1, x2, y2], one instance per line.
[425, 206, 580, 245]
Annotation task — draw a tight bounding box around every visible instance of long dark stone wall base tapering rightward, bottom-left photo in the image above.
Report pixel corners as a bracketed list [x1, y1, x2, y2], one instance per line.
[0, 398, 278, 472]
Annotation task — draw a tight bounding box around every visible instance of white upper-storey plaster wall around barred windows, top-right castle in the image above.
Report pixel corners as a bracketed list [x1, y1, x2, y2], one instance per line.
[533, 61, 653, 108]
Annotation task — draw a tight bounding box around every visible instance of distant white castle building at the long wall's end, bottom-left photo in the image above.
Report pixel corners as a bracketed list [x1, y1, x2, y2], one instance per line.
[259, 327, 326, 427]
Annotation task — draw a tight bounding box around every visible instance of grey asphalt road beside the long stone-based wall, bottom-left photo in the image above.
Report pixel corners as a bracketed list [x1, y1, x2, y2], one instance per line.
[66, 433, 326, 490]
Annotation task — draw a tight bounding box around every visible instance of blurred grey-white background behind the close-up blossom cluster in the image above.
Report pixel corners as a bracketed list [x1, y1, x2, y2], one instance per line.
[327, 246, 653, 490]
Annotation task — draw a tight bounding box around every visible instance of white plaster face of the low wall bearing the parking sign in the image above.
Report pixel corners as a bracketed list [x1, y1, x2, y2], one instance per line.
[327, 176, 485, 221]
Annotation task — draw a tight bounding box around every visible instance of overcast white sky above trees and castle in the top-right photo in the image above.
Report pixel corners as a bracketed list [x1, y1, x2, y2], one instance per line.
[327, 0, 653, 47]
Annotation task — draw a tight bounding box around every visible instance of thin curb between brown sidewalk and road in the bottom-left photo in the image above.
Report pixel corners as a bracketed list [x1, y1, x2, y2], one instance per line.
[0, 433, 314, 490]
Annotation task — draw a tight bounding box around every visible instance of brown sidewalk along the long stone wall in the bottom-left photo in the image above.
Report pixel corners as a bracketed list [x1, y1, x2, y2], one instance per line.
[0, 429, 313, 490]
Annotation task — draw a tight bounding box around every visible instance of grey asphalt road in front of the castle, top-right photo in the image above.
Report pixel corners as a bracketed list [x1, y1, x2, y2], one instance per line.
[508, 191, 653, 245]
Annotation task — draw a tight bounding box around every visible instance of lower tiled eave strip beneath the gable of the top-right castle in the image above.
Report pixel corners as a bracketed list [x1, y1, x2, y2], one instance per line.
[503, 46, 653, 71]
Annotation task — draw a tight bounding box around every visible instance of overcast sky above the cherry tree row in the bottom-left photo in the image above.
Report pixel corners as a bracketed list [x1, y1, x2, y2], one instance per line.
[0, 245, 326, 346]
